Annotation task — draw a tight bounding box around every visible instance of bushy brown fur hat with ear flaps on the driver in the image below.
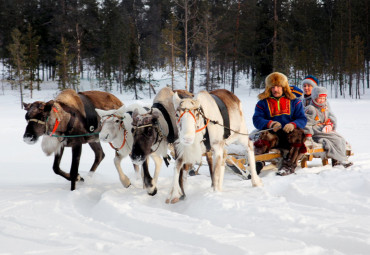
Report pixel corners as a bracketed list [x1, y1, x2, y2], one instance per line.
[258, 72, 296, 100]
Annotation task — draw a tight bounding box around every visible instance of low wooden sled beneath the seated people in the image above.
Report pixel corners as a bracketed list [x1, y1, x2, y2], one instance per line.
[226, 142, 354, 176]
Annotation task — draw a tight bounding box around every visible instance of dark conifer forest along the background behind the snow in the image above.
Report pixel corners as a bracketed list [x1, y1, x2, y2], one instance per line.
[0, 0, 370, 98]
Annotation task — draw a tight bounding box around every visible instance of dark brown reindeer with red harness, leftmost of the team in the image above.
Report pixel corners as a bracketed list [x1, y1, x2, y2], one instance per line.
[23, 89, 123, 190]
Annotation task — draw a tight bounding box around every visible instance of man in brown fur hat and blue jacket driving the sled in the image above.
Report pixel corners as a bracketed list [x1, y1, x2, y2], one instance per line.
[253, 72, 307, 175]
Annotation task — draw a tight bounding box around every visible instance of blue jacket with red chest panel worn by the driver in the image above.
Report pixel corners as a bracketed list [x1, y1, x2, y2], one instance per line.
[253, 96, 307, 130]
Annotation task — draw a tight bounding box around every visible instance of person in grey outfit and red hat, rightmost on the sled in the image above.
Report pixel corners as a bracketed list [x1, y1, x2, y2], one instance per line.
[305, 87, 353, 168]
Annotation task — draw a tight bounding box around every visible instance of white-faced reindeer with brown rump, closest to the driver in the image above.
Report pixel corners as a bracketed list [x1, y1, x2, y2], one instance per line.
[166, 89, 262, 203]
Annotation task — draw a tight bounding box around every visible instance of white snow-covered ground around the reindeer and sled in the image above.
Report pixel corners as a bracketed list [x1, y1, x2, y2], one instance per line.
[0, 79, 370, 255]
